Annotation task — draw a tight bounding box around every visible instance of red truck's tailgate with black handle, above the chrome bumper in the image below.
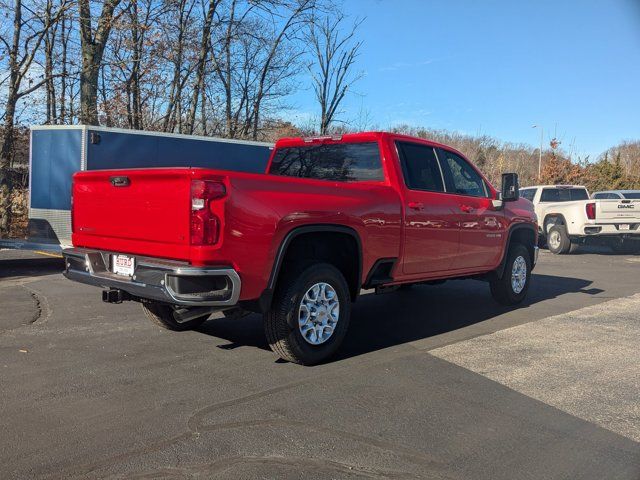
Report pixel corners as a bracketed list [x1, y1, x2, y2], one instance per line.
[72, 168, 192, 258]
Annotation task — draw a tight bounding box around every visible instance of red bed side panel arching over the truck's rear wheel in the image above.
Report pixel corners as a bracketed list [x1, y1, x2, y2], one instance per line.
[205, 174, 401, 299]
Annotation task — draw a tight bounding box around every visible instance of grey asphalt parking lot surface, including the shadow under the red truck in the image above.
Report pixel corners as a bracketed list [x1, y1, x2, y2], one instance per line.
[0, 250, 640, 480]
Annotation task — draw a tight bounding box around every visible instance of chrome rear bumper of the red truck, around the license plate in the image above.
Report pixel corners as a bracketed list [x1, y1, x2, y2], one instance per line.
[62, 248, 242, 307]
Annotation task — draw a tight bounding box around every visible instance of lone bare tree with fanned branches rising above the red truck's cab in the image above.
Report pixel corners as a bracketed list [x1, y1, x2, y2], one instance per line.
[307, 13, 362, 135]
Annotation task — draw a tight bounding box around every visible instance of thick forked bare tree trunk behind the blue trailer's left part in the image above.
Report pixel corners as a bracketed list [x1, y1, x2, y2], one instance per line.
[78, 0, 120, 125]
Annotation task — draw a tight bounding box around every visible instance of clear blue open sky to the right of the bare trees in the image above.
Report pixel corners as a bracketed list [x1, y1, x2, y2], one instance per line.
[292, 0, 640, 159]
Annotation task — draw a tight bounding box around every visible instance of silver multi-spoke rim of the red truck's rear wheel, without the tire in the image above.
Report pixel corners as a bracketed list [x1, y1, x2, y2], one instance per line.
[298, 282, 340, 345]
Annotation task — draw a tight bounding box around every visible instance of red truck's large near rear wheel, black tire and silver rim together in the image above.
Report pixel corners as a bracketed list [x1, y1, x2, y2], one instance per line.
[264, 263, 351, 365]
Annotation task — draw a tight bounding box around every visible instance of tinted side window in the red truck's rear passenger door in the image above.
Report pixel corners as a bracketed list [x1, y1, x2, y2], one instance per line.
[396, 142, 444, 192]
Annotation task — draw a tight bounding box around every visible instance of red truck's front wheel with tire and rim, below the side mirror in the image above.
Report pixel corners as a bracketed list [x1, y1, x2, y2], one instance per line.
[490, 243, 531, 305]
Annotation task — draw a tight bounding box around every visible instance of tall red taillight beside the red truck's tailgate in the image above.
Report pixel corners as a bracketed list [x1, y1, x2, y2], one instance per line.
[191, 180, 227, 245]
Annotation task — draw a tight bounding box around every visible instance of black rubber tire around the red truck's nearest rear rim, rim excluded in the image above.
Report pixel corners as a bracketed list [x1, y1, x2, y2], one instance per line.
[264, 263, 351, 365]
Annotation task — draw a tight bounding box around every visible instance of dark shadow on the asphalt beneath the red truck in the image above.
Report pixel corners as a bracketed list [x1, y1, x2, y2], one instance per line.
[198, 274, 602, 362]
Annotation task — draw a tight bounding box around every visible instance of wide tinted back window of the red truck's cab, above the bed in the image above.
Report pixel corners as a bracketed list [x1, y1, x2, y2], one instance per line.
[269, 142, 384, 182]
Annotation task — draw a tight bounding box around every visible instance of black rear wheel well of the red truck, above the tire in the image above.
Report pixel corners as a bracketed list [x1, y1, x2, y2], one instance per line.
[276, 231, 361, 300]
